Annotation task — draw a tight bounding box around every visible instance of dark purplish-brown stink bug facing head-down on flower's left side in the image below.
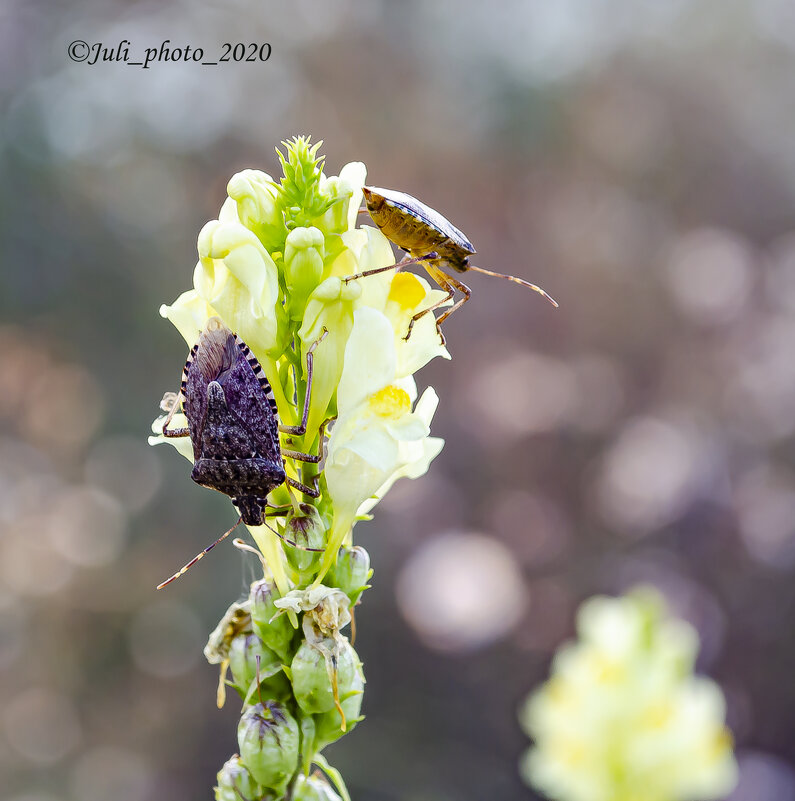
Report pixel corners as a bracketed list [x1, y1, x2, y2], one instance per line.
[158, 317, 323, 589]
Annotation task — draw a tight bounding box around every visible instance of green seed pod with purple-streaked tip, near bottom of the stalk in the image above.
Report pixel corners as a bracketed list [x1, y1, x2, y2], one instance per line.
[237, 701, 300, 796]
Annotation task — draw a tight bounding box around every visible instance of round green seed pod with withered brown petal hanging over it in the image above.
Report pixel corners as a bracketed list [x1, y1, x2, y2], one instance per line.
[291, 635, 360, 714]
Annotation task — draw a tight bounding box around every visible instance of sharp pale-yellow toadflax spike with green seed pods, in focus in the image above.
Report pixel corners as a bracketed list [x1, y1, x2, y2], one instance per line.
[150, 137, 450, 801]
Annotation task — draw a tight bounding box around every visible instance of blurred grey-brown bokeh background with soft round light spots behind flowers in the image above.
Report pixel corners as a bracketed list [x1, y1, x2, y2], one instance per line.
[0, 0, 795, 801]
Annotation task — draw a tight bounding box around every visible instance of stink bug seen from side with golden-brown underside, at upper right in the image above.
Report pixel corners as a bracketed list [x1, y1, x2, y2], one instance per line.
[345, 186, 558, 343]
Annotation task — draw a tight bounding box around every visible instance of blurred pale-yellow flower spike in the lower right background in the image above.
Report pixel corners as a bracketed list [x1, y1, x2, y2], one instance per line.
[521, 589, 737, 801]
